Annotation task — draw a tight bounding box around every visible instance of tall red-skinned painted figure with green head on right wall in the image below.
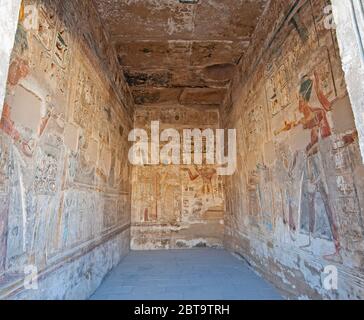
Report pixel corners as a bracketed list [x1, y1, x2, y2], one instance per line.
[299, 63, 340, 258]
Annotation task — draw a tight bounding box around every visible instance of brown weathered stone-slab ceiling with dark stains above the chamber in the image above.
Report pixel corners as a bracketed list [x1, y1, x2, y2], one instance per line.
[94, 0, 268, 105]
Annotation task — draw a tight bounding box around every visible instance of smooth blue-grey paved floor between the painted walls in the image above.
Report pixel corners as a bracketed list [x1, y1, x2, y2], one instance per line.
[91, 249, 281, 300]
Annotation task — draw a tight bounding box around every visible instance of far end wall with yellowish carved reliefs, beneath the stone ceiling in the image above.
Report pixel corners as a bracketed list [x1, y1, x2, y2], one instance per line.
[131, 105, 224, 250]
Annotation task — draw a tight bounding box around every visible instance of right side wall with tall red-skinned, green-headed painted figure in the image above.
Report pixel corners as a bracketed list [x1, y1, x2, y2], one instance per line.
[224, 0, 364, 299]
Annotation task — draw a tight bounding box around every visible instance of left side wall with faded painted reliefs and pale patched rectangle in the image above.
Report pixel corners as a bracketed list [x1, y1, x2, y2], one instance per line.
[0, 1, 133, 299]
